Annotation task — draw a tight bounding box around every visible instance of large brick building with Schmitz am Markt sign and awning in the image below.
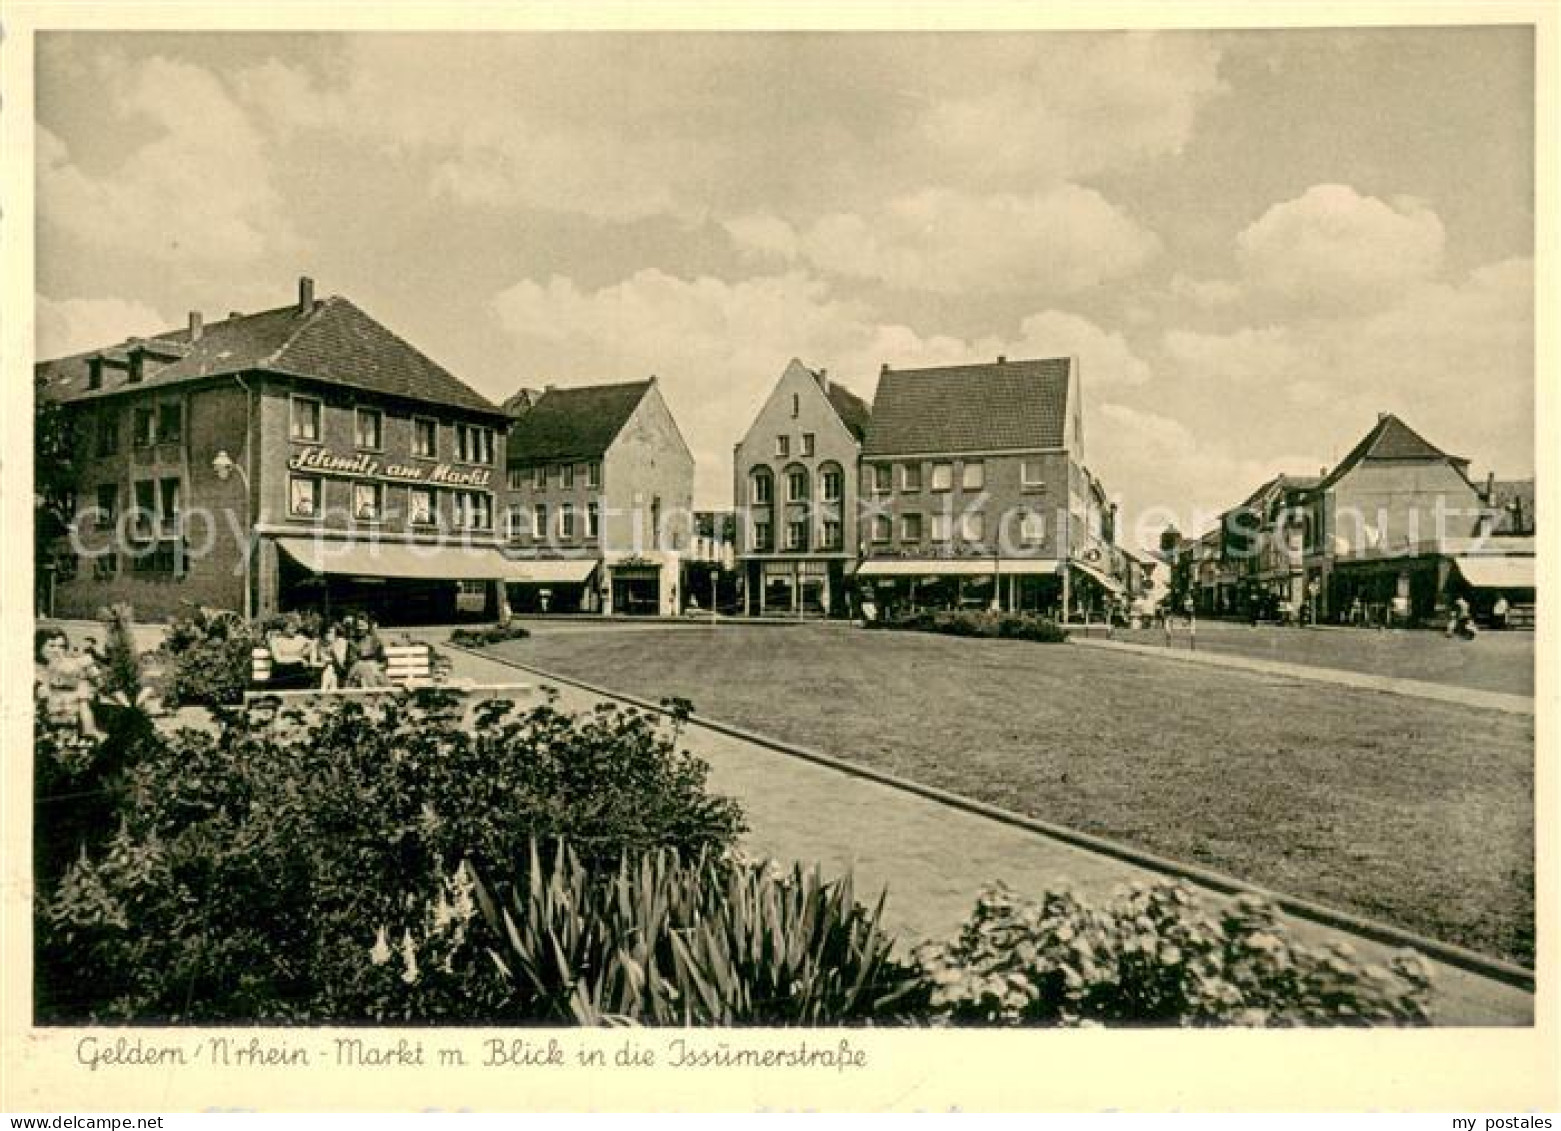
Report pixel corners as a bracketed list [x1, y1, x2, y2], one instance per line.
[37, 279, 507, 622]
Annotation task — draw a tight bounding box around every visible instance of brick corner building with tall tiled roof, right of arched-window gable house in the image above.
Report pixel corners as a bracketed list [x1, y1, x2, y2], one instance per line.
[857, 357, 1127, 615]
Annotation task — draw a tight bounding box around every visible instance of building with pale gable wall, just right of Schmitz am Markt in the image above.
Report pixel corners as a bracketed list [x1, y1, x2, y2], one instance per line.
[504, 378, 693, 616]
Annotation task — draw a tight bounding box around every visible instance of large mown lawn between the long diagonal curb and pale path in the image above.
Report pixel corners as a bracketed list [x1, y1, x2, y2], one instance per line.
[493, 626, 1534, 963]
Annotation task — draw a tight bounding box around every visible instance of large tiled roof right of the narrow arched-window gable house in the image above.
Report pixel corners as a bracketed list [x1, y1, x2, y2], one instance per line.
[862, 357, 1069, 456]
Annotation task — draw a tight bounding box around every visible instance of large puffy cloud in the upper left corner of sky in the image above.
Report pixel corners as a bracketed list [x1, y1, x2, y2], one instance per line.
[37, 56, 292, 265]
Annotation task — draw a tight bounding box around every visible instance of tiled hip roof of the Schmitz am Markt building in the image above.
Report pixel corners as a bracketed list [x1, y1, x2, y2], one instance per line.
[37, 296, 500, 413]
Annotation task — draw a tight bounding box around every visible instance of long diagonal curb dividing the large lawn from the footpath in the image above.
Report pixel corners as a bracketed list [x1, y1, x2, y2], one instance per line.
[446, 644, 1534, 994]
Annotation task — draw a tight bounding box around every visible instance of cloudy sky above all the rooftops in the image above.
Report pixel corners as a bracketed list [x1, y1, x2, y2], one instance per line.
[36, 28, 1534, 529]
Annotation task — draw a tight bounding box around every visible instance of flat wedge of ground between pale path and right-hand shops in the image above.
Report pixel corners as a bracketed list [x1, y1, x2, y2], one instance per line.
[1116, 621, 1534, 696]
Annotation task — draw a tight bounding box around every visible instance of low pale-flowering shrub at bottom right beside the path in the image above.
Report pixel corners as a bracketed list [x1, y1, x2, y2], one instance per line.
[918, 883, 1430, 1026]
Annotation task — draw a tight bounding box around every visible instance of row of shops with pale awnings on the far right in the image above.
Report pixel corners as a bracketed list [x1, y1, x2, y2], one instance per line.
[1160, 413, 1534, 627]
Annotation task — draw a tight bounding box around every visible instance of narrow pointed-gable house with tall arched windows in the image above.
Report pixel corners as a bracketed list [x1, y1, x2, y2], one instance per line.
[732, 357, 868, 616]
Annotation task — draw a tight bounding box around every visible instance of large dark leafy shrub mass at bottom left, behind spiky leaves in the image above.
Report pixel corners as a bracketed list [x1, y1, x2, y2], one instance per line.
[37, 691, 741, 1022]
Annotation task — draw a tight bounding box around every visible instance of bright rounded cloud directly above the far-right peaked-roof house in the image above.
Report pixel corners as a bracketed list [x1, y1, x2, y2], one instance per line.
[1236, 184, 1445, 309]
